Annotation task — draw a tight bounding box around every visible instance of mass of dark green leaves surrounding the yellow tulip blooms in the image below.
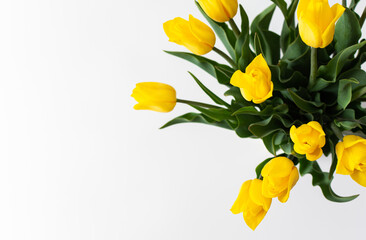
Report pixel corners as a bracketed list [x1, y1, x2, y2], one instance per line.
[162, 0, 366, 202]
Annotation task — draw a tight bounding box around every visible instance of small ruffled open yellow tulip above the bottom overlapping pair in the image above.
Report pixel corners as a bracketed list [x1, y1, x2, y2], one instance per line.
[290, 121, 325, 161]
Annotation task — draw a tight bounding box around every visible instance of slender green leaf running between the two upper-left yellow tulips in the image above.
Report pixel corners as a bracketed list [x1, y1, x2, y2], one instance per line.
[195, 1, 237, 59]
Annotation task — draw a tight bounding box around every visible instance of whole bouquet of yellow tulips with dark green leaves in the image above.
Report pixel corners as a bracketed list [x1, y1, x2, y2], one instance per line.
[132, 0, 366, 230]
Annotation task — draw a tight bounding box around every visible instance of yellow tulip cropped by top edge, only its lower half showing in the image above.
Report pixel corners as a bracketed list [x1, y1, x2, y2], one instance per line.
[198, 0, 238, 22]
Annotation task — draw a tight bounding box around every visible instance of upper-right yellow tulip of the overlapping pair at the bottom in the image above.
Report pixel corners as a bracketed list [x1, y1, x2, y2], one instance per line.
[261, 157, 299, 203]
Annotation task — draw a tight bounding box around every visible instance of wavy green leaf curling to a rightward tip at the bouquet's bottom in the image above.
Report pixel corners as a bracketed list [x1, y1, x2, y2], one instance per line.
[300, 158, 359, 202]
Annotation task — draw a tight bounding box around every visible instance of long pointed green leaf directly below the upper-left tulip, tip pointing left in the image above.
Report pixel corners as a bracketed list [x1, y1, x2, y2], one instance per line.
[165, 51, 234, 85]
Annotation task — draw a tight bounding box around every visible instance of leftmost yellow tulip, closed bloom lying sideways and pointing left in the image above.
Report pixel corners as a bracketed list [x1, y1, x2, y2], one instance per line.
[131, 82, 177, 112]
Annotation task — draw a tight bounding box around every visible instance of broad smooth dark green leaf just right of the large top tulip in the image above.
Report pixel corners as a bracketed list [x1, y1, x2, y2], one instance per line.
[334, 8, 362, 52]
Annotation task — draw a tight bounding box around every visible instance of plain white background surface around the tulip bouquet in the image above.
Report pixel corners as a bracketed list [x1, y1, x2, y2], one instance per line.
[0, 0, 366, 240]
